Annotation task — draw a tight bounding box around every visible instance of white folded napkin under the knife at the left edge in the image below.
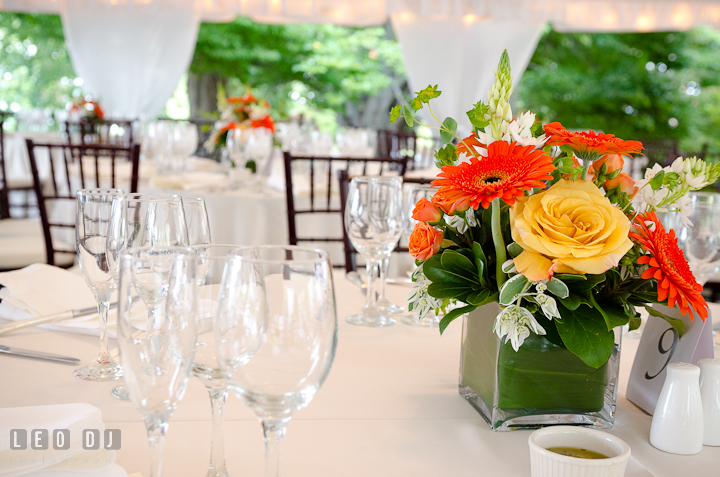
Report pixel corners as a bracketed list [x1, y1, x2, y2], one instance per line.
[0, 263, 116, 338]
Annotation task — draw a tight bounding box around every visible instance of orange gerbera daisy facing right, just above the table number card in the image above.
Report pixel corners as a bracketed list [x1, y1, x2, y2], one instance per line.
[629, 211, 708, 321]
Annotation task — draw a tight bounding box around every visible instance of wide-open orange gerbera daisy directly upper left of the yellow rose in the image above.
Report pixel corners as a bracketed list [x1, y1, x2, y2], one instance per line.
[432, 141, 555, 209]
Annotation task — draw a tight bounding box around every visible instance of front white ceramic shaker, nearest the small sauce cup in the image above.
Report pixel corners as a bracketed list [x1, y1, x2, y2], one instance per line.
[650, 363, 703, 455]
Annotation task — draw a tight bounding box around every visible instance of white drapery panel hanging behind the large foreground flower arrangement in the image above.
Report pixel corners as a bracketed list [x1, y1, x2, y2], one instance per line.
[392, 15, 544, 133]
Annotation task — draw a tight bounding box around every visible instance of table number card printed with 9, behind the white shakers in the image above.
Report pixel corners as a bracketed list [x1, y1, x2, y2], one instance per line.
[626, 305, 714, 414]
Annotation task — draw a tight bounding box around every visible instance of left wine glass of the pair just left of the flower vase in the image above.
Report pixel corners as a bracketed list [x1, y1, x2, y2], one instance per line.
[345, 176, 403, 326]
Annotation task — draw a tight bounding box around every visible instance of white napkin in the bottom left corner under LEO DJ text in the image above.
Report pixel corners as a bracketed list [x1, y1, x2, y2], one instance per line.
[0, 403, 127, 477]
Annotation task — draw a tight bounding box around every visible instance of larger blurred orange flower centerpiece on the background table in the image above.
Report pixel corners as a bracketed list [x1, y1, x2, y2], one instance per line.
[205, 92, 275, 172]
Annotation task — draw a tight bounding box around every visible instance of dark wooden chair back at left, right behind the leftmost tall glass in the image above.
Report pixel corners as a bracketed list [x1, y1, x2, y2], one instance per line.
[27, 139, 140, 266]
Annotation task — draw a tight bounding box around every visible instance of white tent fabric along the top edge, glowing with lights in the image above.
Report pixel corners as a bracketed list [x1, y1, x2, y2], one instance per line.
[0, 0, 720, 31]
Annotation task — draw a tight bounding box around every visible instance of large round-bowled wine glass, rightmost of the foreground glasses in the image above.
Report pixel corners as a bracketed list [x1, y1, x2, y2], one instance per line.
[215, 246, 337, 477]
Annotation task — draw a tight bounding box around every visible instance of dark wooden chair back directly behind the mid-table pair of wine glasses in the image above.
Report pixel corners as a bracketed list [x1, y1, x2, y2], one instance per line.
[284, 152, 408, 266]
